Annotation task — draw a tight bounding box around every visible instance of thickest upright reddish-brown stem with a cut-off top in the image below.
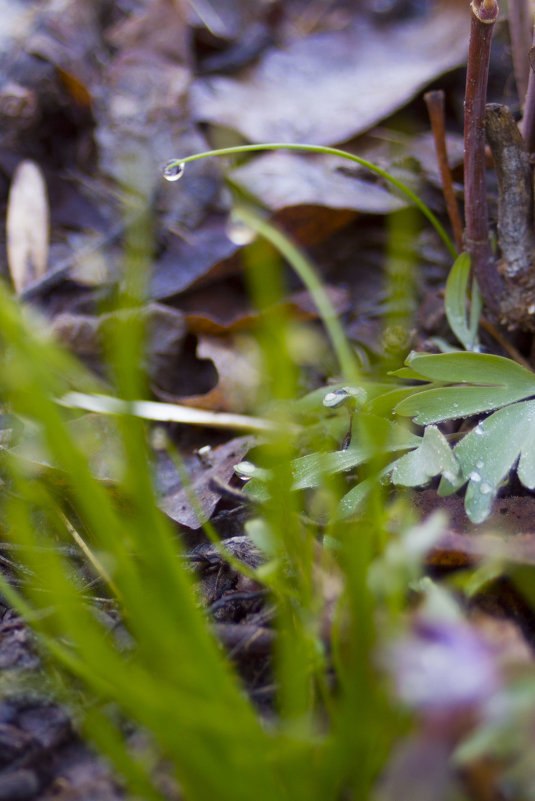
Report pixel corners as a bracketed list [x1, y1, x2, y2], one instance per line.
[464, 0, 501, 317]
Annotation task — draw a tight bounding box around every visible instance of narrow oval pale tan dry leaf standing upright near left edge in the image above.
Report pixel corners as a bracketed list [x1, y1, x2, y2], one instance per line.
[6, 161, 50, 292]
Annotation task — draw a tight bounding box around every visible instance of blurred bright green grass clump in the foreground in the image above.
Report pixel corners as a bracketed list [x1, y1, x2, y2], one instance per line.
[0, 158, 440, 801]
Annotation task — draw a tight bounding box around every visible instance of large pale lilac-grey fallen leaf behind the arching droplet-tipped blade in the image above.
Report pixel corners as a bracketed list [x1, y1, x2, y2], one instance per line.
[191, 0, 469, 145]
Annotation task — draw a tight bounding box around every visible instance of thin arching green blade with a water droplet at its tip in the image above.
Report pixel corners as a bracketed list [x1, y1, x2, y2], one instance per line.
[163, 142, 457, 257]
